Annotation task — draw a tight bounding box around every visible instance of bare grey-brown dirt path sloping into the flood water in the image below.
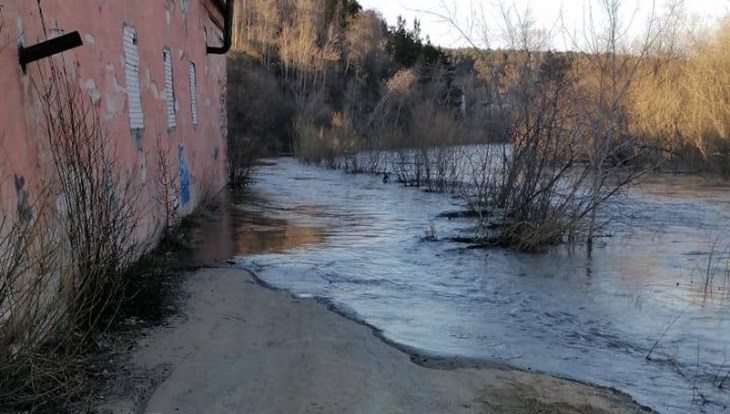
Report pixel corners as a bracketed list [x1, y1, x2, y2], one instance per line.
[102, 268, 646, 414]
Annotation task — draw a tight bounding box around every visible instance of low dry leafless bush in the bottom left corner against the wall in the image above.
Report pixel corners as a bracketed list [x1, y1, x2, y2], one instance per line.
[0, 194, 84, 410]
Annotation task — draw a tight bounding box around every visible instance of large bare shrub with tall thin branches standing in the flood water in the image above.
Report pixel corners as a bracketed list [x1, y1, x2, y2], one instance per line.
[426, 0, 662, 252]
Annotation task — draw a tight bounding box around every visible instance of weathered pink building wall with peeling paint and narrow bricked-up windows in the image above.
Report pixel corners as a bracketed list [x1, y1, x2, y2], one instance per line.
[0, 0, 226, 233]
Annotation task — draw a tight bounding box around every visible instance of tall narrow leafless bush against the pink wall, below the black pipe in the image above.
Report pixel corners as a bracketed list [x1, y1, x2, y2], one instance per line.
[37, 61, 148, 332]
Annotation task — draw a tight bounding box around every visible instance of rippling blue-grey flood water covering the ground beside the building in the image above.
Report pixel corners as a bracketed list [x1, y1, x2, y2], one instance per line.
[225, 159, 730, 413]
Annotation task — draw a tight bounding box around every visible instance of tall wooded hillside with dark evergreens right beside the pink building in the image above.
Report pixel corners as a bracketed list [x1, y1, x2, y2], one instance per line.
[228, 0, 461, 181]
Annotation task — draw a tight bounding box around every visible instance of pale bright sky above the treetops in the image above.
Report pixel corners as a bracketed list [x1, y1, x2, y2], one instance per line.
[358, 0, 730, 49]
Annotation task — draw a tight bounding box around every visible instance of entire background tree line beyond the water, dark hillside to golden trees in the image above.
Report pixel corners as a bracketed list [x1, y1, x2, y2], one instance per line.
[229, 0, 730, 183]
